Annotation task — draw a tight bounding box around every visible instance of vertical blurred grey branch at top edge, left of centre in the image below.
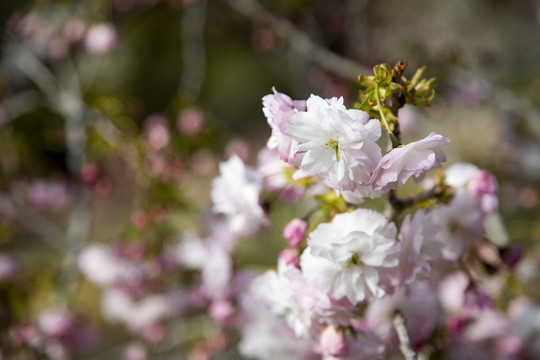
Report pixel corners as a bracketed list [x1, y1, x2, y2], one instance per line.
[178, 0, 206, 97]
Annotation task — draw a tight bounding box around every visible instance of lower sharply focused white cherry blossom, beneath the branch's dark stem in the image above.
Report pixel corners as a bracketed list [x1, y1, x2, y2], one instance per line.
[300, 209, 399, 304]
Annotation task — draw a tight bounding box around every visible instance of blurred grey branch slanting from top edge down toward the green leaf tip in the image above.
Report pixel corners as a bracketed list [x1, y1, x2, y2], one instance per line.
[228, 0, 371, 81]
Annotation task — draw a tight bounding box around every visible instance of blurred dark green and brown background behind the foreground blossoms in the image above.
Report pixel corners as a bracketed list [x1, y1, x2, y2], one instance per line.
[0, 0, 540, 359]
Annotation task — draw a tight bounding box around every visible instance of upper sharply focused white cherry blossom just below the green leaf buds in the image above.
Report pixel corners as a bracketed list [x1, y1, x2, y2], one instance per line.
[286, 95, 381, 191]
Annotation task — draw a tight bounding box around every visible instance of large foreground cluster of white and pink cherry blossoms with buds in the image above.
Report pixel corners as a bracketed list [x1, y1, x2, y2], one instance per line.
[220, 83, 530, 359]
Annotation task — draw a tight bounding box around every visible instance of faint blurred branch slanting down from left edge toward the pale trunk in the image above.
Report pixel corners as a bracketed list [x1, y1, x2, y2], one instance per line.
[0, 192, 66, 250]
